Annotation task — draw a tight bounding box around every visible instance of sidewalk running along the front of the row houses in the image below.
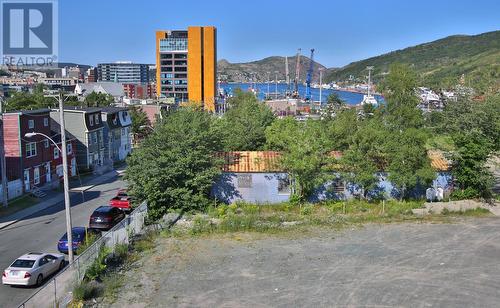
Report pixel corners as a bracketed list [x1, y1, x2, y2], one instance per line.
[0, 170, 123, 230]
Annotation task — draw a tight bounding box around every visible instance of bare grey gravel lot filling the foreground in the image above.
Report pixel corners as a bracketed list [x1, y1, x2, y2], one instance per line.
[113, 218, 500, 308]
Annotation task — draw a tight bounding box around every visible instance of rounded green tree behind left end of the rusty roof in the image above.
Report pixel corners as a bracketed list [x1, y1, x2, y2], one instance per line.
[218, 90, 274, 151]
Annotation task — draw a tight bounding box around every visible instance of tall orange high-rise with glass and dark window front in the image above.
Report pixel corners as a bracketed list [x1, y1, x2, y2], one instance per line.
[156, 26, 217, 111]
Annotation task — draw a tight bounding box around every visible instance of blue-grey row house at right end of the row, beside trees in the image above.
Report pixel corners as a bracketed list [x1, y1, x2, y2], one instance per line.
[101, 107, 132, 162]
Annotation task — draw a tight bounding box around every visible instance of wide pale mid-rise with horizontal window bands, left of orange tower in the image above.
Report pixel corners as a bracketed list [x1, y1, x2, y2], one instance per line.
[97, 61, 149, 83]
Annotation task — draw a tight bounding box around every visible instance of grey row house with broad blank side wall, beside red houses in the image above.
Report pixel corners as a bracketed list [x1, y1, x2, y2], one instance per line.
[50, 107, 105, 169]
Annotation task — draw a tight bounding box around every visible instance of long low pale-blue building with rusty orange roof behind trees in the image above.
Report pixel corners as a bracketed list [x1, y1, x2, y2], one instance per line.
[211, 151, 453, 203]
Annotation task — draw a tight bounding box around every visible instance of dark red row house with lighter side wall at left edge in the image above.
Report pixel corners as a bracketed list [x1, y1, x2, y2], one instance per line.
[3, 109, 52, 192]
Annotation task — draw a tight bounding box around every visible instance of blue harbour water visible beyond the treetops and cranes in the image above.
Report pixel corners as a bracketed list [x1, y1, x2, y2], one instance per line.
[220, 83, 384, 105]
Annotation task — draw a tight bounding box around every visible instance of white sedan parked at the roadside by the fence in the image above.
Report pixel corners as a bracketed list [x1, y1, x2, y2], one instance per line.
[2, 252, 65, 286]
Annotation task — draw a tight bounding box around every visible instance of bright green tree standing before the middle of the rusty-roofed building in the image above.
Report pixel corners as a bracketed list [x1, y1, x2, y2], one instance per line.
[266, 117, 331, 201]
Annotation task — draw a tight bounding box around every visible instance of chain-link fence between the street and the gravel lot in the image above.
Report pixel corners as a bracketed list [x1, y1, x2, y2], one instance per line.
[19, 202, 148, 308]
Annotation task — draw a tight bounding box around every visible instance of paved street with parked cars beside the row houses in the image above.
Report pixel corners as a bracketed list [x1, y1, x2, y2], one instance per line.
[0, 177, 125, 308]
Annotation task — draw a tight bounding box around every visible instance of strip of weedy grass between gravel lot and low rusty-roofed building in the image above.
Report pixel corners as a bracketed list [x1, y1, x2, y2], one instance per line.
[169, 200, 485, 237]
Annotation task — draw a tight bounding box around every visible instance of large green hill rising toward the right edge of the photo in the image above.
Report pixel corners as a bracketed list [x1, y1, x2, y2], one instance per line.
[326, 31, 500, 92]
